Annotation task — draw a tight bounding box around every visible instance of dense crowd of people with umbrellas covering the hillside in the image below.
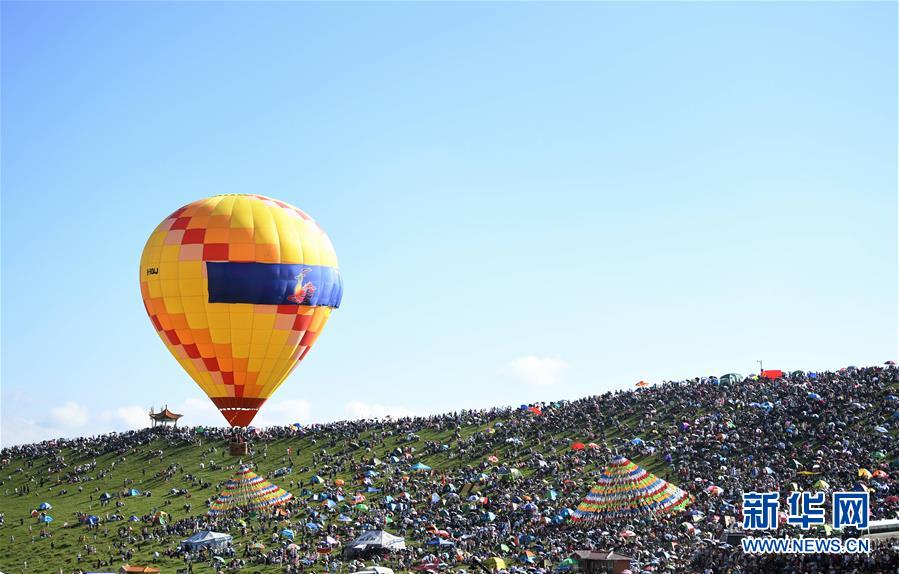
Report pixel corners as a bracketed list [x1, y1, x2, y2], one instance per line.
[0, 365, 899, 573]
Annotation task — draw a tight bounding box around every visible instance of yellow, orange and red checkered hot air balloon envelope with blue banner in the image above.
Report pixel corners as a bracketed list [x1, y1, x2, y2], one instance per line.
[140, 195, 343, 427]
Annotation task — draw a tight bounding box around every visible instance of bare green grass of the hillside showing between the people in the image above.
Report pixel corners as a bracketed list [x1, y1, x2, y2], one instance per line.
[0, 382, 899, 574]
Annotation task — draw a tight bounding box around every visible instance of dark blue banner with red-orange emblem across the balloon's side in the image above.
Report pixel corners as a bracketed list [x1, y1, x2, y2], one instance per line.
[206, 261, 343, 308]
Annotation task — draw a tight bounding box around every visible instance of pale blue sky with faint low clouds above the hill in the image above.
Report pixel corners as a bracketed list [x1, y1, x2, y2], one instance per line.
[2, 2, 897, 444]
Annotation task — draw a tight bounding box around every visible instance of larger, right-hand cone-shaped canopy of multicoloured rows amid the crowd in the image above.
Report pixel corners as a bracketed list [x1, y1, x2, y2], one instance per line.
[573, 456, 693, 520]
